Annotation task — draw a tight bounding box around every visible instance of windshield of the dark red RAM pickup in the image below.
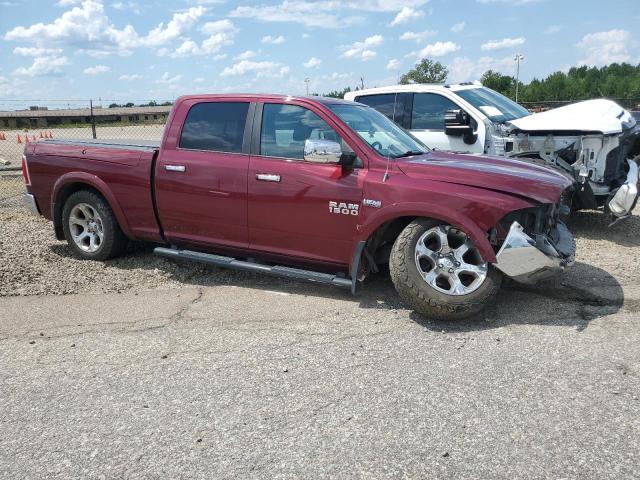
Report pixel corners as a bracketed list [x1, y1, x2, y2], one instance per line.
[329, 105, 429, 158]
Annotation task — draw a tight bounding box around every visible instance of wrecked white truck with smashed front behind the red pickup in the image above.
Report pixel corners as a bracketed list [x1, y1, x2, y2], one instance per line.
[344, 83, 640, 218]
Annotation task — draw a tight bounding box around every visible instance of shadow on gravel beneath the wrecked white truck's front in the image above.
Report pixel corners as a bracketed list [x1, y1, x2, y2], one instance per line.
[567, 210, 640, 247]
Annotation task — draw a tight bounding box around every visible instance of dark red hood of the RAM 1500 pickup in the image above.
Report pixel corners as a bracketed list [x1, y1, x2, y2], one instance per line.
[398, 151, 572, 203]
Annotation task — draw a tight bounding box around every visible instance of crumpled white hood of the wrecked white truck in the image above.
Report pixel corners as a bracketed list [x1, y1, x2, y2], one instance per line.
[507, 99, 636, 135]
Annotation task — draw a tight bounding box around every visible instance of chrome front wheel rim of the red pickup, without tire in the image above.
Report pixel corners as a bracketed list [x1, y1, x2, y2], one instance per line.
[415, 225, 488, 295]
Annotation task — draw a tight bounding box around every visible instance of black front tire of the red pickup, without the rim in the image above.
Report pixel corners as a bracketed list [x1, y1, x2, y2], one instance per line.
[389, 219, 502, 320]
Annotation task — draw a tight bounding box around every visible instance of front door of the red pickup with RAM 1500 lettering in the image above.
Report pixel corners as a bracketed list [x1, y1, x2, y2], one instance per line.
[248, 104, 366, 265]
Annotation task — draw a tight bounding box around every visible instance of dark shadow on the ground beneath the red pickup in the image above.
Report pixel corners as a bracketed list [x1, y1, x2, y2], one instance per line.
[51, 244, 624, 333]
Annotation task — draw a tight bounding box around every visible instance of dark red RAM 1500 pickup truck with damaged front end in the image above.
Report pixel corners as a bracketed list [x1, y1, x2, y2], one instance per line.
[23, 95, 575, 318]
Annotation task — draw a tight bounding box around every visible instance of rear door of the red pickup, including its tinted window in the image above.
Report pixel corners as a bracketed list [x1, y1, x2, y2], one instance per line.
[155, 102, 252, 248]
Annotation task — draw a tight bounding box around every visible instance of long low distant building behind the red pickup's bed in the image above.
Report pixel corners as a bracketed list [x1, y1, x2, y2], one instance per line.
[0, 105, 171, 129]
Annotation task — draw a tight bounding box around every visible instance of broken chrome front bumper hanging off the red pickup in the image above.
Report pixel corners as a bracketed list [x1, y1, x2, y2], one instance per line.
[494, 222, 575, 284]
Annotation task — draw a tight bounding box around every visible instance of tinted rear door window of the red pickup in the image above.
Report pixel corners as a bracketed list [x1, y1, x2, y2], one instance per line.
[180, 102, 249, 153]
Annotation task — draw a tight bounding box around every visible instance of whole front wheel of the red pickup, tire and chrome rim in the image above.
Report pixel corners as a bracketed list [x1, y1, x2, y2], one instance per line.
[389, 219, 502, 320]
